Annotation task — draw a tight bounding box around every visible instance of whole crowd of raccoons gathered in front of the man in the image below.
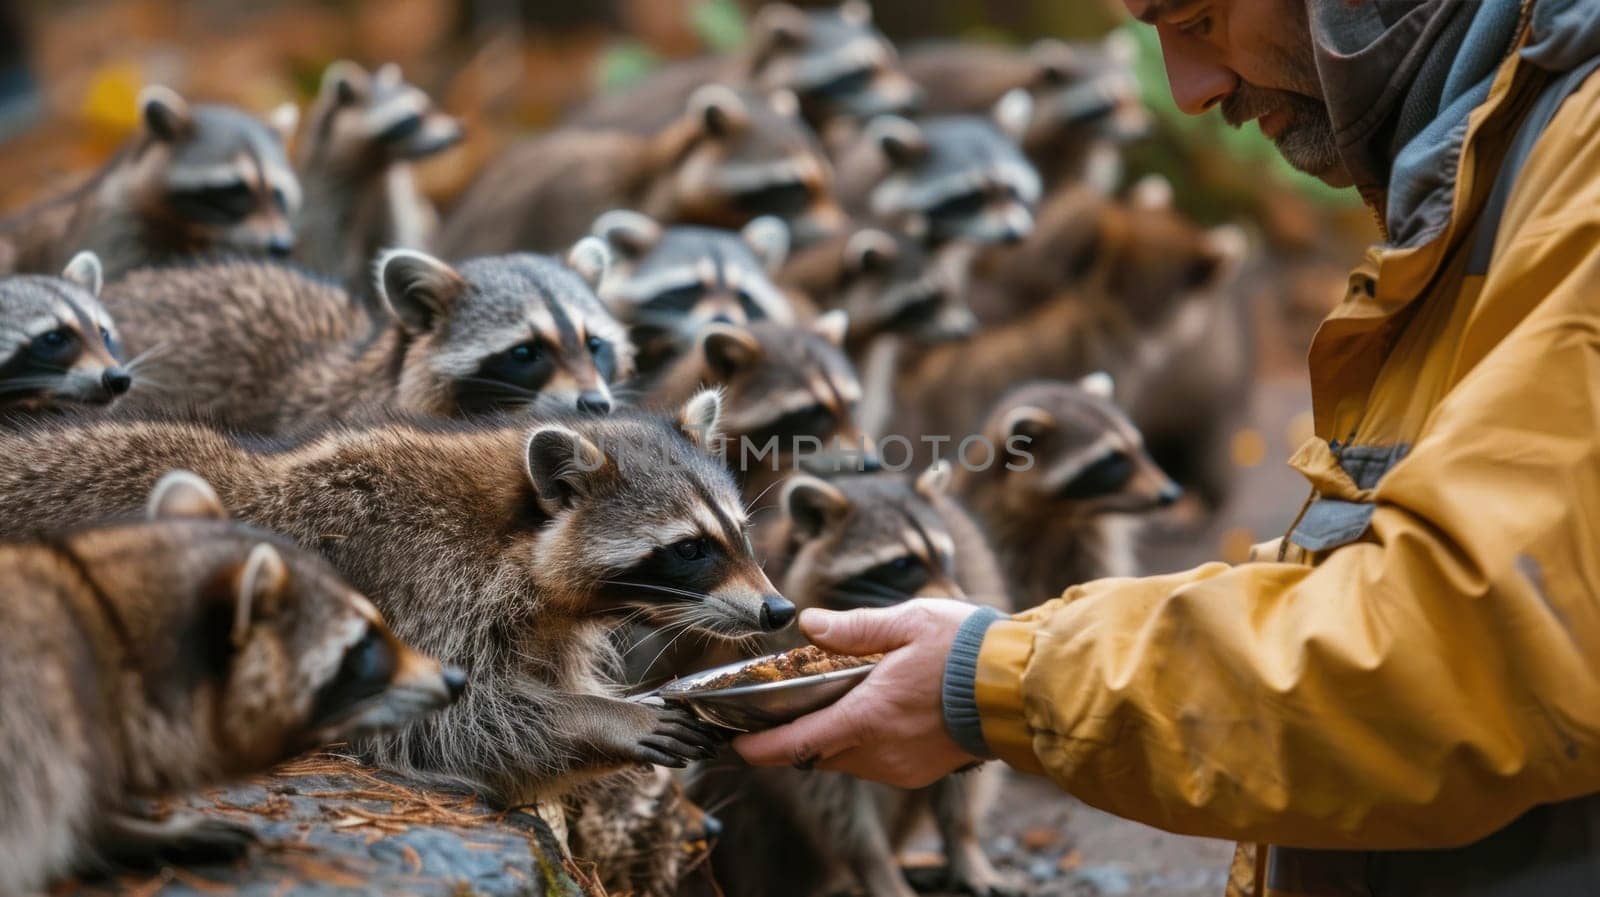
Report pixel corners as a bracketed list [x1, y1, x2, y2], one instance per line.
[0, 2, 1248, 897]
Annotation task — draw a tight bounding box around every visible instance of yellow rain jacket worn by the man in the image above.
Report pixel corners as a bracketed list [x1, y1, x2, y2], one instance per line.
[974, 6, 1600, 897]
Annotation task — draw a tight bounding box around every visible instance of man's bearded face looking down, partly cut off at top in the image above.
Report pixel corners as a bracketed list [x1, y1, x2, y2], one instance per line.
[1123, 0, 1350, 185]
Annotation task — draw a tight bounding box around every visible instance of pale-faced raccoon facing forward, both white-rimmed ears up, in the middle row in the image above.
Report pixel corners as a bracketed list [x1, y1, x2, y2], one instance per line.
[592, 209, 797, 381]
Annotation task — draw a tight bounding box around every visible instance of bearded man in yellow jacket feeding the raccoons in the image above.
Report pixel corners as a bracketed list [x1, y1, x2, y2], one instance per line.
[736, 0, 1600, 897]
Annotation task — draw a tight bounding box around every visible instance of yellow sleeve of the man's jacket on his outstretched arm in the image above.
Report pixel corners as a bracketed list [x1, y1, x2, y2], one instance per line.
[974, 206, 1600, 849]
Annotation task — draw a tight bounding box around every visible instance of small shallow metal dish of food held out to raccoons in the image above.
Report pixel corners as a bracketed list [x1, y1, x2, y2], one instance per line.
[658, 654, 877, 732]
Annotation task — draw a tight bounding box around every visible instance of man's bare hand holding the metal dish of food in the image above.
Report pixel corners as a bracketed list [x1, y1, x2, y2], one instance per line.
[733, 598, 978, 788]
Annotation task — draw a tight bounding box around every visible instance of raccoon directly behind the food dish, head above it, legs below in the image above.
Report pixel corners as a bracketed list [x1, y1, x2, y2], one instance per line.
[690, 464, 1010, 897]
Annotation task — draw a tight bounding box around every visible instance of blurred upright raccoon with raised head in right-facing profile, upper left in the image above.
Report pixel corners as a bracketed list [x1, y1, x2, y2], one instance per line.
[294, 61, 464, 297]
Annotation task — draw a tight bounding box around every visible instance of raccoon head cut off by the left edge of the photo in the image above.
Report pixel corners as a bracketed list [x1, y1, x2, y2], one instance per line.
[0, 253, 133, 417]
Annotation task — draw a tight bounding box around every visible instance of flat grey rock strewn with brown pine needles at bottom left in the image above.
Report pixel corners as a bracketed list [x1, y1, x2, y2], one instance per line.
[51, 755, 598, 897]
